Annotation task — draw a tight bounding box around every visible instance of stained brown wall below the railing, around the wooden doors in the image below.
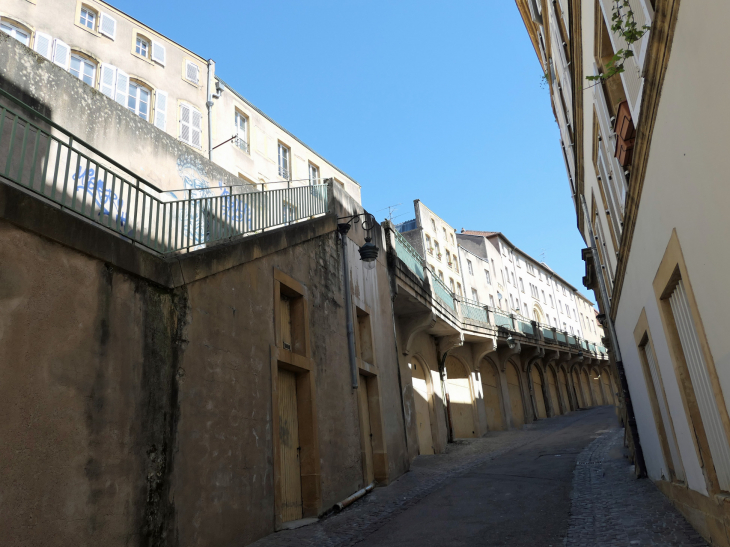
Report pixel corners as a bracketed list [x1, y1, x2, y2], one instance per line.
[0, 179, 409, 545]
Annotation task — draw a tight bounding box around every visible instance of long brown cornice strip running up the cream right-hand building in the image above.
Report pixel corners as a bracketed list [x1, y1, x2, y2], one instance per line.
[610, 0, 680, 320]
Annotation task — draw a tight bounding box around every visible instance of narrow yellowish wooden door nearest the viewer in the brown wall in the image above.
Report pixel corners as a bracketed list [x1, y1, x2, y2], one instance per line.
[278, 369, 302, 522]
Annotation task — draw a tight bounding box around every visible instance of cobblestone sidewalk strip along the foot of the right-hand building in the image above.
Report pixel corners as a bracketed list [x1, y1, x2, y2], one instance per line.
[565, 428, 707, 547]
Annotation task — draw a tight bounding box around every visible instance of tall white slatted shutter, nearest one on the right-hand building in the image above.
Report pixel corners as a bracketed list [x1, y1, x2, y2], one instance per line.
[669, 279, 730, 492]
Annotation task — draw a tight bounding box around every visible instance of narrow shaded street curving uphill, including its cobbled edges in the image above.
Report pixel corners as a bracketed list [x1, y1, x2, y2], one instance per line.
[254, 406, 706, 547]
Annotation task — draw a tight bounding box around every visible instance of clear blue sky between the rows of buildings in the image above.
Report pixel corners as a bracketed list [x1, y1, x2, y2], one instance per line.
[112, 0, 593, 299]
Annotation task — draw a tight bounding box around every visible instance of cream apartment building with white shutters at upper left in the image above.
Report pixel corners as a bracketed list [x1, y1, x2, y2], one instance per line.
[0, 0, 361, 203]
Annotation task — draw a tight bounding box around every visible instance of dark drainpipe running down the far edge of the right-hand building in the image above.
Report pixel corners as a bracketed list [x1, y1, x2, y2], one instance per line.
[580, 194, 646, 477]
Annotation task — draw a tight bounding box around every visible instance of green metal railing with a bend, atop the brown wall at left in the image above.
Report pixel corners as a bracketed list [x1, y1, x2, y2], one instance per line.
[0, 96, 328, 254]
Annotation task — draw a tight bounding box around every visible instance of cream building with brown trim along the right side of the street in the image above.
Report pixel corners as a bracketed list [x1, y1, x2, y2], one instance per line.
[516, 0, 730, 545]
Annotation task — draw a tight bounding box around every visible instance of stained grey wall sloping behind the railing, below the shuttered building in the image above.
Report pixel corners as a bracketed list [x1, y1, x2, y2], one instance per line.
[0, 33, 250, 195]
